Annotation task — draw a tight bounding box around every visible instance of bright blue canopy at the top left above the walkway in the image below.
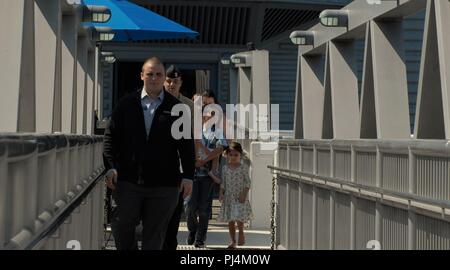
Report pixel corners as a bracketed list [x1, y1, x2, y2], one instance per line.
[83, 0, 198, 41]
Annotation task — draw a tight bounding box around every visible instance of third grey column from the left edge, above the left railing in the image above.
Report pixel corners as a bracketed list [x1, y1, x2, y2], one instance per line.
[61, 14, 78, 133]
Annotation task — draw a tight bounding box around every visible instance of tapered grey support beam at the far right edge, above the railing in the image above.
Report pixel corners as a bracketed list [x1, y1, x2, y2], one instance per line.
[414, 0, 450, 139]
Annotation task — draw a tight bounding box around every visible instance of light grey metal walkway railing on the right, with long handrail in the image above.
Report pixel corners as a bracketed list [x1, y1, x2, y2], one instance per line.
[271, 140, 450, 249]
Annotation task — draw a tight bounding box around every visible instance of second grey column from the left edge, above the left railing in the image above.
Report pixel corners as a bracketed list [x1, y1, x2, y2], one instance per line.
[34, 0, 61, 133]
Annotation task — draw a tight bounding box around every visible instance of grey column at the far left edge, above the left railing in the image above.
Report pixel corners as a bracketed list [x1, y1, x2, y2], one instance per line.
[0, 1, 36, 132]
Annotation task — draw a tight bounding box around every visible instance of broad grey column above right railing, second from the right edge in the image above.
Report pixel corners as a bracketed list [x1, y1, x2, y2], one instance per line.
[361, 21, 410, 139]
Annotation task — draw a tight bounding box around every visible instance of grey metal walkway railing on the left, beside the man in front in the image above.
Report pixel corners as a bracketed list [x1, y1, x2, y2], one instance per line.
[0, 134, 104, 249]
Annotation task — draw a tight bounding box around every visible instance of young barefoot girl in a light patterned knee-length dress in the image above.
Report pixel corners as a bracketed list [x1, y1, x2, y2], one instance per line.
[209, 142, 253, 248]
